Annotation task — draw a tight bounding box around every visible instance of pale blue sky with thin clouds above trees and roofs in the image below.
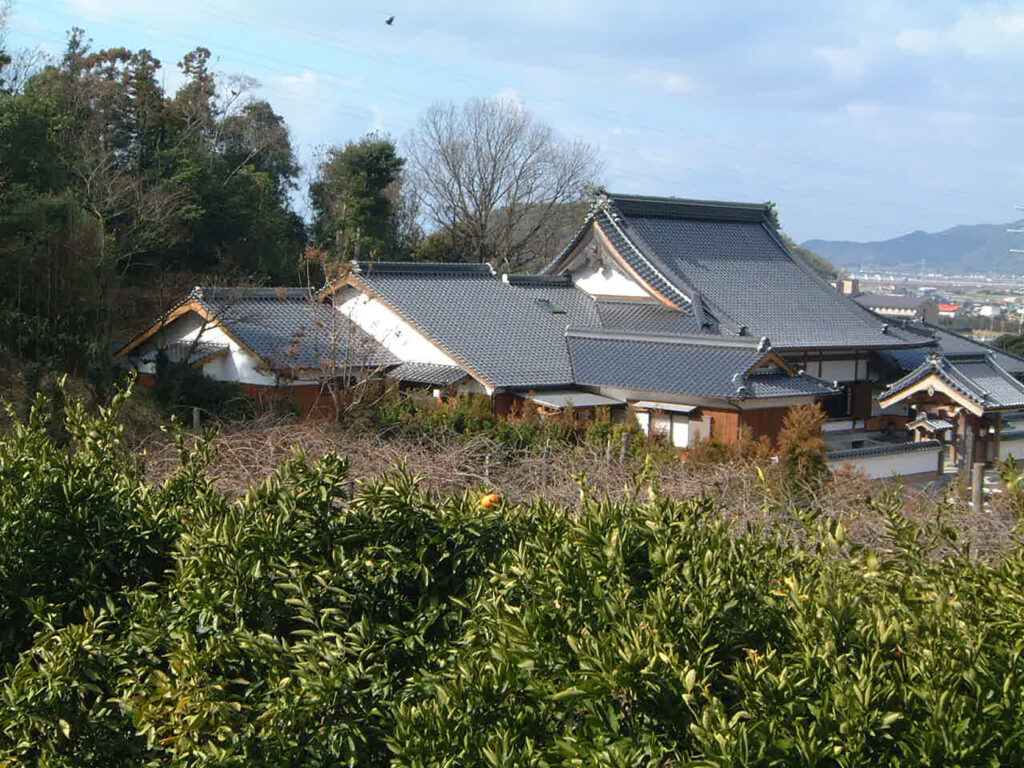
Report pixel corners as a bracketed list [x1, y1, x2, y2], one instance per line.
[7, 0, 1024, 241]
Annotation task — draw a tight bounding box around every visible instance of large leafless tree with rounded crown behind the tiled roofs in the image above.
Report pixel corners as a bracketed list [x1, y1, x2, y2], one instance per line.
[408, 99, 600, 269]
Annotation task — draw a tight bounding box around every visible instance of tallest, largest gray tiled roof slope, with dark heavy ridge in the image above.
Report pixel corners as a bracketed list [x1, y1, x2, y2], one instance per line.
[548, 196, 927, 349]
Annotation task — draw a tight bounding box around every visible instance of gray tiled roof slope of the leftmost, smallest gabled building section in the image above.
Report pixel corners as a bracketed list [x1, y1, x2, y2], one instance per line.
[189, 288, 398, 373]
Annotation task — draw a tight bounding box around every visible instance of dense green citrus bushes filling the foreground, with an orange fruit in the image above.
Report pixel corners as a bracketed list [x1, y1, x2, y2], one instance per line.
[0, 397, 1024, 768]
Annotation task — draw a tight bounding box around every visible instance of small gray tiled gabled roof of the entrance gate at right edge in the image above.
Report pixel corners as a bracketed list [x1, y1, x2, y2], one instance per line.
[879, 354, 1024, 411]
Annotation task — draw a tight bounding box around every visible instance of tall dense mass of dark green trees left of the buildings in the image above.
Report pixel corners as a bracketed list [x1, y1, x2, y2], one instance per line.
[0, 29, 306, 378]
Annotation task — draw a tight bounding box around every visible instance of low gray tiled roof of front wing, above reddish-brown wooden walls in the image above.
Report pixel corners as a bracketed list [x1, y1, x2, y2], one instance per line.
[566, 329, 834, 399]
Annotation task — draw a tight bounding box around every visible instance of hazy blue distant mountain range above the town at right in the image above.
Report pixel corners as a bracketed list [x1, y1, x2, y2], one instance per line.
[801, 219, 1024, 274]
